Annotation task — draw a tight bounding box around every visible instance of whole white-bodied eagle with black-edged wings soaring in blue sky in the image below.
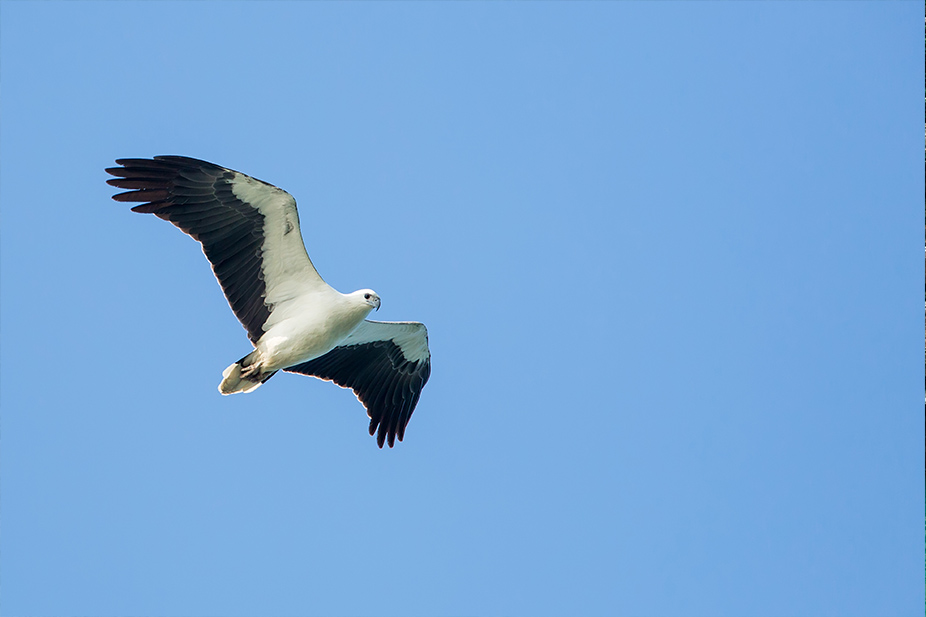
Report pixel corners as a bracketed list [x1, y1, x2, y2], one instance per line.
[106, 156, 431, 448]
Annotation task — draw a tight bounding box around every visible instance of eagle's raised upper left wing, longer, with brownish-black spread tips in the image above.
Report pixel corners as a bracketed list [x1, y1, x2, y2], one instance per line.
[106, 156, 327, 343]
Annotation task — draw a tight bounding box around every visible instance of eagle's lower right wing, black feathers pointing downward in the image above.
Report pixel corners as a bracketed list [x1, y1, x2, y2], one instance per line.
[284, 321, 431, 448]
